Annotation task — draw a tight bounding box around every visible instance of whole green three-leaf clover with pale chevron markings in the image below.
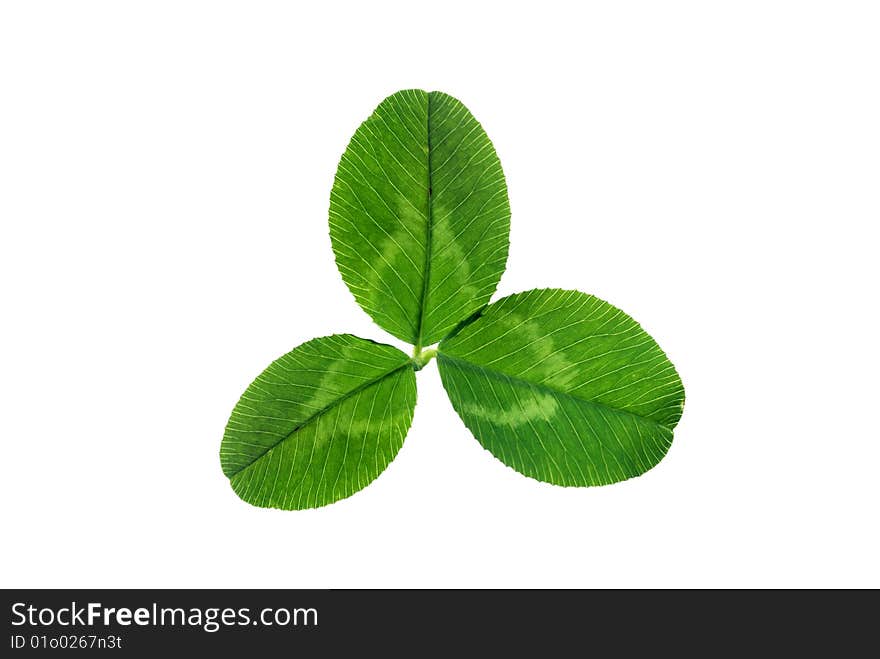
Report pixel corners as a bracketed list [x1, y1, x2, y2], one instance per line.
[220, 90, 684, 510]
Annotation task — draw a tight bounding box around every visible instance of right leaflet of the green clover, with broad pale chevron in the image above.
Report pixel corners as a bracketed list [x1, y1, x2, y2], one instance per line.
[438, 289, 684, 486]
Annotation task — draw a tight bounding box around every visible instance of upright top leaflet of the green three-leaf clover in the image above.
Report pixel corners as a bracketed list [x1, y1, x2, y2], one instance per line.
[330, 90, 510, 347]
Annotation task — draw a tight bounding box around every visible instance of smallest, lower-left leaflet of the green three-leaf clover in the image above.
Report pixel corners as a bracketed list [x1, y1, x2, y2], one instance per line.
[220, 334, 416, 510]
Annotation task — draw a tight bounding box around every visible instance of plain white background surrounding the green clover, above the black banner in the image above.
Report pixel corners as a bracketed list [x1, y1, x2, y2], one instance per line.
[0, 0, 880, 587]
